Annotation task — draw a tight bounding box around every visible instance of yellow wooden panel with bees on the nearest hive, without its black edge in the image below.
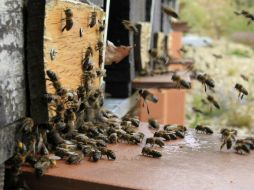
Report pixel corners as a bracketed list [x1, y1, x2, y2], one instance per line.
[44, 0, 105, 92]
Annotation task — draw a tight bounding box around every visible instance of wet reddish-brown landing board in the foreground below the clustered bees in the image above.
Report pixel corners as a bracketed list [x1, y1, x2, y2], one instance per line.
[22, 124, 254, 190]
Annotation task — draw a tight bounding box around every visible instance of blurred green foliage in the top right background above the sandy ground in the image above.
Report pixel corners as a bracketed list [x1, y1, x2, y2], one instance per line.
[180, 0, 254, 38]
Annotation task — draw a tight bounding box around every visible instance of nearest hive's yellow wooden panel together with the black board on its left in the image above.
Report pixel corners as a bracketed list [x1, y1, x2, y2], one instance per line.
[27, 0, 105, 123]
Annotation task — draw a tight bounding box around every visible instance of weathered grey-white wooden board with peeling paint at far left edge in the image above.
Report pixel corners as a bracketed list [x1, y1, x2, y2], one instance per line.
[0, 0, 26, 127]
